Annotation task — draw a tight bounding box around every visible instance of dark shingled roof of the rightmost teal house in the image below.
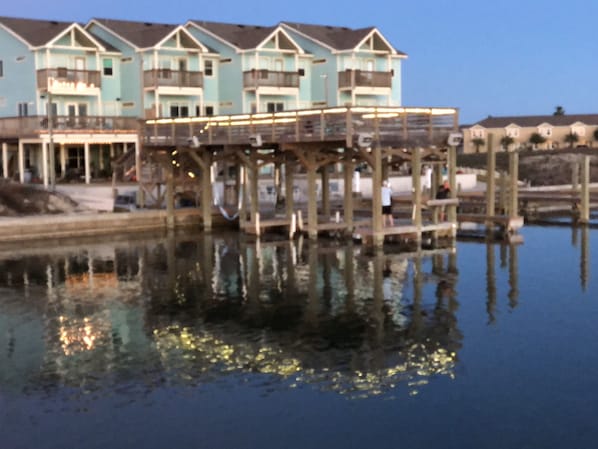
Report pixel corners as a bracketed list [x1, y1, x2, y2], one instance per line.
[281, 22, 407, 56]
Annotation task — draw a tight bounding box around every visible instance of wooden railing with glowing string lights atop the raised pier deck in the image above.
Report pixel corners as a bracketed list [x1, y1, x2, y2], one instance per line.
[143, 106, 458, 147]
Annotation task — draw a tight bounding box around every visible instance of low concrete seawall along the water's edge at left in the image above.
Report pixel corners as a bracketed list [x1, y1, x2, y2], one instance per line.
[0, 209, 201, 242]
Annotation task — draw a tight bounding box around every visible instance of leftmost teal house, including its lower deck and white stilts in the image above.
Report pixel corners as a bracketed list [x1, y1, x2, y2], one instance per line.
[0, 17, 138, 183]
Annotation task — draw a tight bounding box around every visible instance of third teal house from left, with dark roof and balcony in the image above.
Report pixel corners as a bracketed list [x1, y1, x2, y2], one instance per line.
[186, 20, 312, 114]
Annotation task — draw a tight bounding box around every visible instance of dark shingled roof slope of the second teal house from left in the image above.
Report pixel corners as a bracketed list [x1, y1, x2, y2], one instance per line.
[91, 18, 180, 48]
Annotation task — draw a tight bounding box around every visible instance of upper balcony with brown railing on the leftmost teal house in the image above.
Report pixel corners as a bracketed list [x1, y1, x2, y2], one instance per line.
[37, 67, 102, 94]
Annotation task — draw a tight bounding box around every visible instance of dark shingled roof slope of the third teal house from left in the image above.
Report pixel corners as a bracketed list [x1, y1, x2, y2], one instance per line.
[188, 20, 278, 50]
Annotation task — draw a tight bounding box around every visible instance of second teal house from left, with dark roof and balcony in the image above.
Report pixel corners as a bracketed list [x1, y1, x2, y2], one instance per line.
[85, 19, 218, 118]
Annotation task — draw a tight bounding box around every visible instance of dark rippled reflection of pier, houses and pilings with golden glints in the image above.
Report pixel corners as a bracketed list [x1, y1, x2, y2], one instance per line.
[0, 233, 536, 397]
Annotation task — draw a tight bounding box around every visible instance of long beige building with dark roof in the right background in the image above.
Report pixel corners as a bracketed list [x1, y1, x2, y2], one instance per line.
[463, 114, 598, 153]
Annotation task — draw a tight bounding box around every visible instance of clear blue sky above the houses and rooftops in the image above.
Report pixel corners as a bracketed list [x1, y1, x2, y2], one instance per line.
[0, 0, 598, 124]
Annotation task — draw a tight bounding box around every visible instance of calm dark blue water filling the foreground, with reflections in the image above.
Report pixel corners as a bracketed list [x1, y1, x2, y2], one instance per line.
[0, 226, 598, 449]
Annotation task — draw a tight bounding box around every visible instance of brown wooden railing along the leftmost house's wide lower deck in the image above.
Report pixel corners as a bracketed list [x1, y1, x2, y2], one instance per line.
[0, 115, 139, 138]
